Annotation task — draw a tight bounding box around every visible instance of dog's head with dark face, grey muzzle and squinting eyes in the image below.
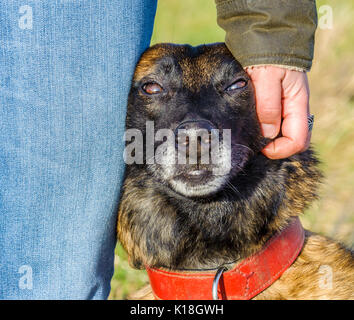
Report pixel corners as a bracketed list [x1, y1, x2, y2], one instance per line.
[126, 43, 264, 197]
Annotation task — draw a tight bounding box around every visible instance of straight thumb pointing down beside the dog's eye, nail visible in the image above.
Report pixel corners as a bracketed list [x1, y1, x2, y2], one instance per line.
[247, 68, 283, 139]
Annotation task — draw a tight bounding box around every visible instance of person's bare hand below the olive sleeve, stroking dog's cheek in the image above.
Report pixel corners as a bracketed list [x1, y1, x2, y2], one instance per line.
[246, 65, 311, 159]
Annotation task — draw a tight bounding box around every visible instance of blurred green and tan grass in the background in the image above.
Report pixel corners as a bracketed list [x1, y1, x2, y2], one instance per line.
[110, 0, 354, 299]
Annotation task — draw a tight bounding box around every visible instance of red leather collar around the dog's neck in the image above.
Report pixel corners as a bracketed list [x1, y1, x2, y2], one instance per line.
[146, 218, 305, 300]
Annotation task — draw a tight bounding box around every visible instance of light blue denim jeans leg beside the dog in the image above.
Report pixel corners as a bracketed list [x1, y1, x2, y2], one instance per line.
[0, 0, 156, 299]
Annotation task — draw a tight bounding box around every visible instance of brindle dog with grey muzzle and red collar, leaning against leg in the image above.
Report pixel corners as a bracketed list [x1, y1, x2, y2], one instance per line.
[117, 43, 354, 299]
